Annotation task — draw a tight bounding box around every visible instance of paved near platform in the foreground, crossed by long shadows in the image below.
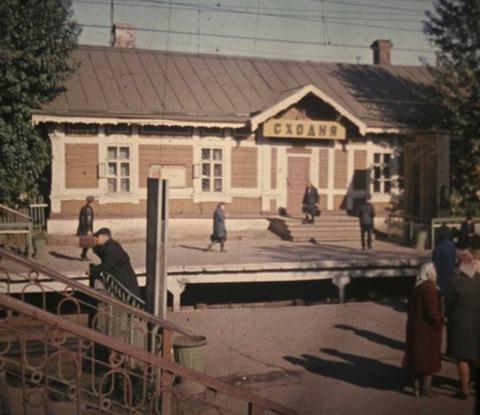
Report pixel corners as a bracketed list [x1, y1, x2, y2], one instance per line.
[169, 303, 473, 415]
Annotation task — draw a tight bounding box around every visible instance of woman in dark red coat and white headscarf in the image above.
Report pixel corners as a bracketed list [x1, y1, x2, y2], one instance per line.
[404, 263, 443, 397]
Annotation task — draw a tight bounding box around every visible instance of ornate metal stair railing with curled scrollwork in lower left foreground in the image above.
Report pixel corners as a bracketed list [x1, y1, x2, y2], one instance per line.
[0, 249, 295, 415]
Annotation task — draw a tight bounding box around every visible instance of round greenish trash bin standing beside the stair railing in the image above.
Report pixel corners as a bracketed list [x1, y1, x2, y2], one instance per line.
[173, 335, 207, 395]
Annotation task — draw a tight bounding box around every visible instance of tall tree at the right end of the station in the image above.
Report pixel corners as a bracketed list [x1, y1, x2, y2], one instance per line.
[424, 0, 480, 214]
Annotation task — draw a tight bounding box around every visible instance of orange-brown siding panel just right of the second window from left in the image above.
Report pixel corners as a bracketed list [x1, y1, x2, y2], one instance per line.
[232, 147, 257, 188]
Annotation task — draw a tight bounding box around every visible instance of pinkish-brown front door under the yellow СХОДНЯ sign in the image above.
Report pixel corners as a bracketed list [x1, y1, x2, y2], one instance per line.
[287, 157, 310, 215]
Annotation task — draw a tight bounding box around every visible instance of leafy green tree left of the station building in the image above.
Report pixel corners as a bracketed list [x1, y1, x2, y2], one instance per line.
[0, 0, 80, 205]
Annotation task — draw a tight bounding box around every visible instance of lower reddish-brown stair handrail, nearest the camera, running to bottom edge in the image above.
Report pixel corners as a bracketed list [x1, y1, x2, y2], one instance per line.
[0, 293, 296, 415]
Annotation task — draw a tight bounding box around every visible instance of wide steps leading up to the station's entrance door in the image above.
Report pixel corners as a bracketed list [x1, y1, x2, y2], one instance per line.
[269, 213, 360, 242]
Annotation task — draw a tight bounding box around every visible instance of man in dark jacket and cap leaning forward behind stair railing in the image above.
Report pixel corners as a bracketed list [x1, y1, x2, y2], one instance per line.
[91, 228, 142, 299]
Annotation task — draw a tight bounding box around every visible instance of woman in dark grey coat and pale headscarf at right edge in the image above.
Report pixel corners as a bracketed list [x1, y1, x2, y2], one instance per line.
[445, 251, 480, 399]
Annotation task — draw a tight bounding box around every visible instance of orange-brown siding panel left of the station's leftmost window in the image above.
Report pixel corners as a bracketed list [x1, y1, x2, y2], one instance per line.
[65, 144, 98, 189]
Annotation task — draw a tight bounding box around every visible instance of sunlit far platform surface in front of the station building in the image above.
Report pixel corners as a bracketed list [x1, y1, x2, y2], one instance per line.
[36, 231, 430, 274]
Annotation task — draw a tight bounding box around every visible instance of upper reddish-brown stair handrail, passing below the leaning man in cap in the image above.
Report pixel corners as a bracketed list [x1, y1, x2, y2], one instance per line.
[0, 248, 192, 336]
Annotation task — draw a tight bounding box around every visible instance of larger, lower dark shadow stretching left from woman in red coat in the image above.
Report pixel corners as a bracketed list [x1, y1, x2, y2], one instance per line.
[284, 348, 457, 392]
